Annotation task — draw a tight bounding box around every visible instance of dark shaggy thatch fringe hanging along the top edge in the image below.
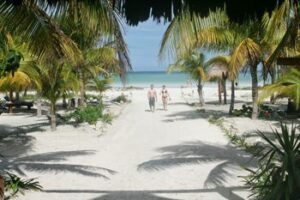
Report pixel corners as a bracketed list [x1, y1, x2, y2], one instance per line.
[111, 0, 283, 25]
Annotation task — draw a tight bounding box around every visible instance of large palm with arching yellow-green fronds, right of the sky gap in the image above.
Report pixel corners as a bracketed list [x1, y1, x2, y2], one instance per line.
[160, 10, 262, 119]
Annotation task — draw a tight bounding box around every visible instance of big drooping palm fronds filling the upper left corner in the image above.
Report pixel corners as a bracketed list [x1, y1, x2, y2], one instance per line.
[0, 0, 130, 75]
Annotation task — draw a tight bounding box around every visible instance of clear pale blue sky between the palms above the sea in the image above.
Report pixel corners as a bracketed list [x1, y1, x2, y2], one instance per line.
[125, 20, 168, 71]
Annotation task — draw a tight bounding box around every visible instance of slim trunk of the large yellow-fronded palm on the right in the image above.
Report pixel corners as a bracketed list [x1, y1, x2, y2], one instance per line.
[250, 64, 258, 119]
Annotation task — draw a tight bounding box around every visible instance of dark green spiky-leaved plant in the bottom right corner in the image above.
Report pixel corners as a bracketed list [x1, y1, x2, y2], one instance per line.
[244, 124, 300, 200]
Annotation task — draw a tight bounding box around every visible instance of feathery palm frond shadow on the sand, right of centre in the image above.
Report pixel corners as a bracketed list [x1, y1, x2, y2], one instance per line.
[138, 141, 256, 187]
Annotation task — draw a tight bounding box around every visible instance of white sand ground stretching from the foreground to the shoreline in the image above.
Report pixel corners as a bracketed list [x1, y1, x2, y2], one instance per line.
[0, 88, 271, 200]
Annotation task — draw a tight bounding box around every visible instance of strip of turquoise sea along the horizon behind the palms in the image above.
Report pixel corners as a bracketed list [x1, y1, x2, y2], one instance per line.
[112, 72, 268, 88]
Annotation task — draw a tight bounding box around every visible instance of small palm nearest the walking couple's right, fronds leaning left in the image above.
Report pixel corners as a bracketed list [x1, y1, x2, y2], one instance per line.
[168, 50, 206, 106]
